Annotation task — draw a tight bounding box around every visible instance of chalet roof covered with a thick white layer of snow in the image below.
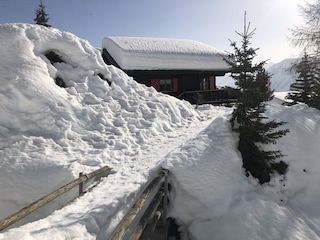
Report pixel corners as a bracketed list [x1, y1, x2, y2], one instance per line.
[102, 37, 229, 72]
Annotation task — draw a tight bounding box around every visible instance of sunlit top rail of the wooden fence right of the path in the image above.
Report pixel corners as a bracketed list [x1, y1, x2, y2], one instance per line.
[109, 171, 165, 240]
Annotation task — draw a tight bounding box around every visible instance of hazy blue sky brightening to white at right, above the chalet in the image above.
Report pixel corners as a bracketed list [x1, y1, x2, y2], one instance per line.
[0, 0, 304, 62]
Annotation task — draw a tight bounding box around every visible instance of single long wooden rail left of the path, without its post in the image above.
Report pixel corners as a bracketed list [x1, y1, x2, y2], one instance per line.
[0, 166, 110, 231]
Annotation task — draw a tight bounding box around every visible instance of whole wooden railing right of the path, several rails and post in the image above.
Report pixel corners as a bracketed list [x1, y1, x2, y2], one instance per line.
[108, 169, 168, 240]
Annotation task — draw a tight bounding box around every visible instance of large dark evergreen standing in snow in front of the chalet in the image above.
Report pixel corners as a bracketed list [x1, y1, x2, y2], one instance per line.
[225, 14, 288, 184]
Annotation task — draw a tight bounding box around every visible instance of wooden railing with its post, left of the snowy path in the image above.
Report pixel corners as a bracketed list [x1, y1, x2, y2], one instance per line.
[0, 166, 111, 231]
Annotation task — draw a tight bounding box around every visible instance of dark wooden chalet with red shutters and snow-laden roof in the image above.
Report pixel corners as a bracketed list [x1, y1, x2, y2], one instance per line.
[102, 37, 229, 103]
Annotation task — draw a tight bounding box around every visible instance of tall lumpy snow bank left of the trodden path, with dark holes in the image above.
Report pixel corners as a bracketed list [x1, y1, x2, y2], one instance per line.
[0, 24, 199, 227]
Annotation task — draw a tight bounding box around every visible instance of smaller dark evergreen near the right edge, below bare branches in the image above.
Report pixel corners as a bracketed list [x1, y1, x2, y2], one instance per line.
[286, 52, 316, 106]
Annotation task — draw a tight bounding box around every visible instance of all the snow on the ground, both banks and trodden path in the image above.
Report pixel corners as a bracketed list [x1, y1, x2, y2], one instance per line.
[0, 24, 320, 240]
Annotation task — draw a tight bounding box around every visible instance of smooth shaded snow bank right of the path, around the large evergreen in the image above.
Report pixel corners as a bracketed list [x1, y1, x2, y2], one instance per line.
[165, 99, 320, 240]
